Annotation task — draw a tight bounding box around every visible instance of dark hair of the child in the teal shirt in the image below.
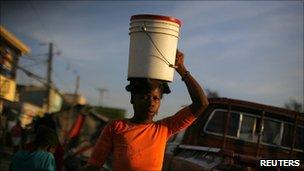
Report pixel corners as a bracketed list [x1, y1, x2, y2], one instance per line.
[33, 125, 59, 147]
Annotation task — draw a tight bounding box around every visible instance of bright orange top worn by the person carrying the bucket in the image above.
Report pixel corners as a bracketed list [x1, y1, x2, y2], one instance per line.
[88, 107, 196, 171]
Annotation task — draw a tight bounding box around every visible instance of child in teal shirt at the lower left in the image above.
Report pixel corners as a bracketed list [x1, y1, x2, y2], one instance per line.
[9, 126, 59, 171]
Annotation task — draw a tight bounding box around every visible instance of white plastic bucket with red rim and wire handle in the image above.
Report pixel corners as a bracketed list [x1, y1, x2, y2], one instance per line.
[128, 15, 181, 82]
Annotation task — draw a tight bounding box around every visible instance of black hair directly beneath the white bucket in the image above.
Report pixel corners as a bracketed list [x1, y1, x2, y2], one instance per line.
[126, 78, 171, 94]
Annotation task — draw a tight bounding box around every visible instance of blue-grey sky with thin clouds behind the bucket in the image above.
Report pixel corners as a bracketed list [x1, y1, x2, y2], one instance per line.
[1, 1, 304, 118]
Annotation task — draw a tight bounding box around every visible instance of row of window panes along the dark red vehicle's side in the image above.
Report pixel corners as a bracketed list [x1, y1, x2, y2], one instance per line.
[204, 109, 304, 151]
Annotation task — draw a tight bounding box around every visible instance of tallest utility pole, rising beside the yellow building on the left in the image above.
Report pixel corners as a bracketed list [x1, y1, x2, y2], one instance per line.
[46, 42, 53, 112]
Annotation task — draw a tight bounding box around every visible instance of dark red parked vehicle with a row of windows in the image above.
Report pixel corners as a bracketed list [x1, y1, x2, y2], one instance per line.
[163, 98, 304, 171]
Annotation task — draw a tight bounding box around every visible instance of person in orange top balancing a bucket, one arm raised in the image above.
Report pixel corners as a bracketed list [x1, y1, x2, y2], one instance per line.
[83, 51, 209, 171]
